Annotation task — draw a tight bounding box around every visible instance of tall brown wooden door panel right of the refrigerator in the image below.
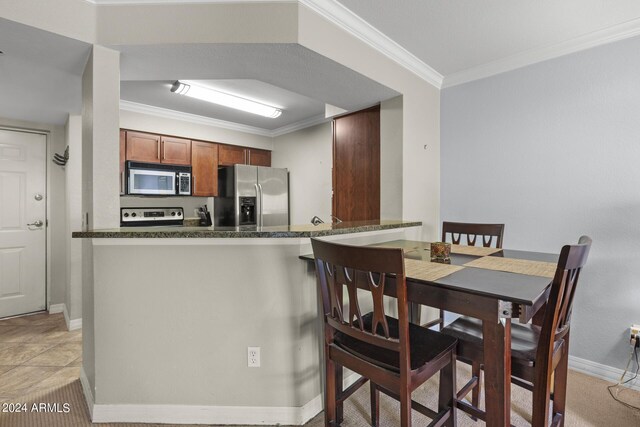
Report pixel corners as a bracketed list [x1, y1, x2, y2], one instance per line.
[332, 106, 380, 221]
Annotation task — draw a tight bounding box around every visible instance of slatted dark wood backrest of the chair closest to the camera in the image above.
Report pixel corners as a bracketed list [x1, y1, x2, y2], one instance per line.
[311, 239, 410, 366]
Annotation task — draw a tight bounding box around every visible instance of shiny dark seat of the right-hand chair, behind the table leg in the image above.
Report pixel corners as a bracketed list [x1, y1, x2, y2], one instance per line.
[442, 316, 540, 365]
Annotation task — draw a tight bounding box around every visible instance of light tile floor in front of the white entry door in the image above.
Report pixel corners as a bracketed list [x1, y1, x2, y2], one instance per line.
[0, 313, 82, 403]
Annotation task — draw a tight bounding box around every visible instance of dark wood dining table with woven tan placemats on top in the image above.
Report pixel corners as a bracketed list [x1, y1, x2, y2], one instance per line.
[300, 240, 558, 427]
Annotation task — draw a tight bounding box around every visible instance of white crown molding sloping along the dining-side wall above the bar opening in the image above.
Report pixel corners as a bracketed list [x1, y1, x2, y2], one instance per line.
[299, 0, 443, 89]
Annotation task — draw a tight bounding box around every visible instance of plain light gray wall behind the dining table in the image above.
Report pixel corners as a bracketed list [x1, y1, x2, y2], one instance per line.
[441, 38, 640, 368]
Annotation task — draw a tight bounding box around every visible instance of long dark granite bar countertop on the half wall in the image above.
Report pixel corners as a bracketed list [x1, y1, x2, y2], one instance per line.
[72, 220, 422, 239]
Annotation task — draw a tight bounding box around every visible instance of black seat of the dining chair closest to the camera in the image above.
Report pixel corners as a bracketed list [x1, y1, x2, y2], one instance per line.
[335, 313, 457, 372]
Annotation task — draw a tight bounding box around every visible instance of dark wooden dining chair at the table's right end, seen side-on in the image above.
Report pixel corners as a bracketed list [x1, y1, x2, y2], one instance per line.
[442, 236, 591, 427]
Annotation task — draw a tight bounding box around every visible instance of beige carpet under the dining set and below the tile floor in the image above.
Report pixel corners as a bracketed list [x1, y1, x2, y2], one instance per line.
[0, 366, 640, 427]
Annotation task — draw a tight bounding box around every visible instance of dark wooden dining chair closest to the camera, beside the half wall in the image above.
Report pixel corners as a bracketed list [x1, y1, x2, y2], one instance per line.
[311, 239, 456, 427]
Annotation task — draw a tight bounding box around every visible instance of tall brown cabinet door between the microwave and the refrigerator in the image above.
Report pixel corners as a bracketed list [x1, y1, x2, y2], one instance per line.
[191, 141, 218, 197]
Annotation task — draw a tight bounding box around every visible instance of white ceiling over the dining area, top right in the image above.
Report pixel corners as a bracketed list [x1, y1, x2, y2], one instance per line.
[337, 0, 640, 80]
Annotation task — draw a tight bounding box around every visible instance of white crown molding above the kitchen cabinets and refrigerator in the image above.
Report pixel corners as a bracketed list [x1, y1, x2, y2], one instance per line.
[120, 100, 329, 138]
